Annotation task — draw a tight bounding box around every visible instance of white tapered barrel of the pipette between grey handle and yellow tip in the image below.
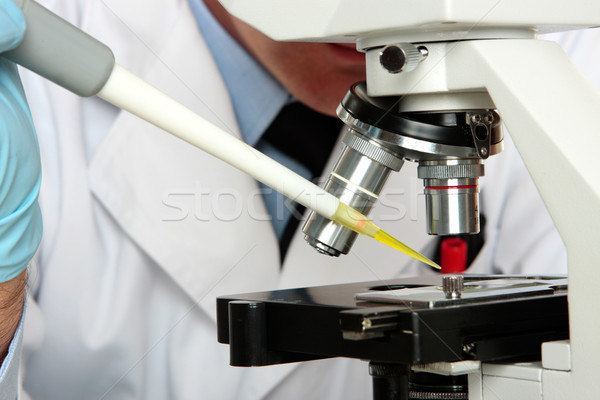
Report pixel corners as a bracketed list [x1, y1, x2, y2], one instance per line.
[97, 64, 339, 219]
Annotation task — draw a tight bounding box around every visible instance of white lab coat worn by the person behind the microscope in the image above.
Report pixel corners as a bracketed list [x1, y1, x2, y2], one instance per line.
[18, 0, 566, 400]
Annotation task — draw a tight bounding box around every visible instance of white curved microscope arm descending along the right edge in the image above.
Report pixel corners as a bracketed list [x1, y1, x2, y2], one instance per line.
[446, 40, 600, 399]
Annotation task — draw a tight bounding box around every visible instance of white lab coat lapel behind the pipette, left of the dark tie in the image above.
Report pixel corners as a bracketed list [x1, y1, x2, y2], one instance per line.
[88, 0, 279, 318]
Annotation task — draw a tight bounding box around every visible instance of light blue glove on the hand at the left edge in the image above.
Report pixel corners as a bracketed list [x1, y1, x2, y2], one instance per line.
[0, 0, 42, 282]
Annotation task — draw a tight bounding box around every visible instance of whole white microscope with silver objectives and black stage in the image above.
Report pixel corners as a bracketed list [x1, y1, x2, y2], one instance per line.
[217, 0, 600, 400]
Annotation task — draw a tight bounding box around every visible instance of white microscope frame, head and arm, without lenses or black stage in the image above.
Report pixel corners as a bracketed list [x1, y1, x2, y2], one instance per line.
[216, 0, 600, 399]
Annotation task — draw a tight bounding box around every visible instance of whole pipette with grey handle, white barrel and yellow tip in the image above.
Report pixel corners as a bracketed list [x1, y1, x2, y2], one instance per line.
[3, 0, 440, 268]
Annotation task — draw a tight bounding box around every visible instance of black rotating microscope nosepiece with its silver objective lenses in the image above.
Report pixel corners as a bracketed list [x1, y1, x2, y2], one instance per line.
[303, 82, 503, 256]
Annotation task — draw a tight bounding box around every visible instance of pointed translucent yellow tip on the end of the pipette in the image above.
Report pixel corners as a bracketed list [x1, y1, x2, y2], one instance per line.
[331, 202, 441, 269]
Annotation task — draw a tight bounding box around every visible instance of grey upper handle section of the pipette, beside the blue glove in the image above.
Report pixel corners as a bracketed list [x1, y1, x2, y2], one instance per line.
[2, 0, 115, 97]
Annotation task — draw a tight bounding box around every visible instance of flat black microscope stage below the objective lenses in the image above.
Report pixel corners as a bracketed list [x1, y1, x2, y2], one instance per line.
[217, 275, 569, 366]
